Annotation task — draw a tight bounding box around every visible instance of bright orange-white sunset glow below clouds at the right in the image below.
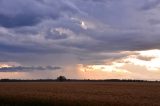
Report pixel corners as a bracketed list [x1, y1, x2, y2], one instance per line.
[77, 50, 160, 79]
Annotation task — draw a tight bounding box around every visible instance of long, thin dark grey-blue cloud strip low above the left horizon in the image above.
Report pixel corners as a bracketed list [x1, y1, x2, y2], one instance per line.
[0, 66, 61, 72]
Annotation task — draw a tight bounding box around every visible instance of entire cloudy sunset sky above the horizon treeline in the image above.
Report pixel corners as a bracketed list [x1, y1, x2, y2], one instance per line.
[0, 0, 160, 80]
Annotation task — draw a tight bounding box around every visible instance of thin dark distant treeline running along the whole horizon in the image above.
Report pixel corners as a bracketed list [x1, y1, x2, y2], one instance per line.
[0, 79, 160, 82]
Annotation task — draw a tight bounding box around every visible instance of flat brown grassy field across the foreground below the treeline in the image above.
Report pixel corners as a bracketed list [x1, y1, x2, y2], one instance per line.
[0, 82, 160, 106]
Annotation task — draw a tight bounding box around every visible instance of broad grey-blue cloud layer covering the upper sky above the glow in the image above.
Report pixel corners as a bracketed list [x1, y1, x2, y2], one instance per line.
[0, 0, 160, 63]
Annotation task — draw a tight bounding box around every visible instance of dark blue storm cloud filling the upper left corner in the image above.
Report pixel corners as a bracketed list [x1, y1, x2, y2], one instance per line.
[0, 0, 76, 28]
